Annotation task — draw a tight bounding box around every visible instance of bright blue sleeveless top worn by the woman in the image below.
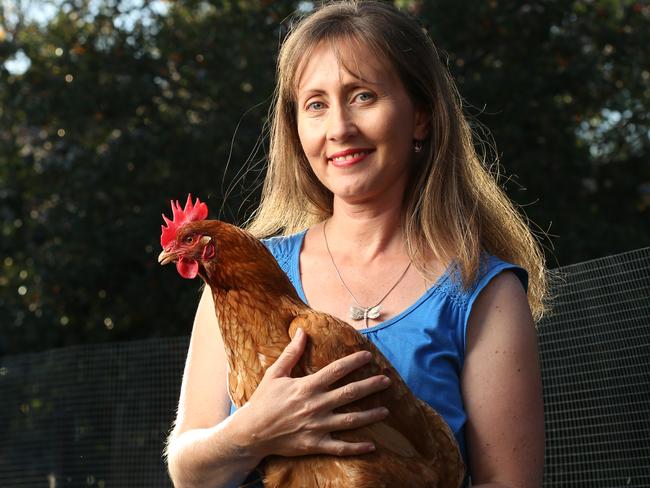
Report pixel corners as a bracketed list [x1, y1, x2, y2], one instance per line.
[231, 230, 528, 474]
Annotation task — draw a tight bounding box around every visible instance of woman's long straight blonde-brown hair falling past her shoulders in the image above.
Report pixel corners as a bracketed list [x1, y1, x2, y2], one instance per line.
[247, 1, 547, 320]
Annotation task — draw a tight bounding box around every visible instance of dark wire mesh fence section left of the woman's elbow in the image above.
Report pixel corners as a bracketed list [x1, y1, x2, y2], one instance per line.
[0, 338, 188, 488]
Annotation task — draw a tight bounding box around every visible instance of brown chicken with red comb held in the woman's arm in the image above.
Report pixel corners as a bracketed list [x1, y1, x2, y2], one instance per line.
[158, 196, 464, 488]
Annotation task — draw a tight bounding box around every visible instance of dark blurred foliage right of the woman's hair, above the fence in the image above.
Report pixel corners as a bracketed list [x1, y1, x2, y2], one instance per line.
[415, 0, 650, 267]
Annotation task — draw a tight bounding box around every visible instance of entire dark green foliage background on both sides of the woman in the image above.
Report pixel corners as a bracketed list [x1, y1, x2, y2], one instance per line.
[0, 0, 650, 354]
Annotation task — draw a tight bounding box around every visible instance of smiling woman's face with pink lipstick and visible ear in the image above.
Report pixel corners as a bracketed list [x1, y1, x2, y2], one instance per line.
[296, 42, 427, 203]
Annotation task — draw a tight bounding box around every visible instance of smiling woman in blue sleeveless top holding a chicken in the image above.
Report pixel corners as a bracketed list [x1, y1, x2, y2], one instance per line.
[168, 2, 545, 487]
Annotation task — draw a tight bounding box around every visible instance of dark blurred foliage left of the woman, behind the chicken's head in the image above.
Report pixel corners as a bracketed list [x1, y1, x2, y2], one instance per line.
[0, 0, 295, 352]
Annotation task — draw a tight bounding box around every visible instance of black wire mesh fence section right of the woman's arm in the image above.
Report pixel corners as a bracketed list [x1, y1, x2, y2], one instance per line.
[539, 248, 650, 488]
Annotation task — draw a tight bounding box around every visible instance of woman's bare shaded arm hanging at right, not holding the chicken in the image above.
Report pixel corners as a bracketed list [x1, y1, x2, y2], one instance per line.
[462, 271, 544, 488]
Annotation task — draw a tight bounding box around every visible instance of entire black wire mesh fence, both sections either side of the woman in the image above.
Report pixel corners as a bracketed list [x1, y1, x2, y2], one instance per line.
[0, 248, 650, 488]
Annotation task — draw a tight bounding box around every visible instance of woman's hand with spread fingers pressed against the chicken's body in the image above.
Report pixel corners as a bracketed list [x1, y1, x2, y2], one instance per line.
[237, 329, 390, 457]
